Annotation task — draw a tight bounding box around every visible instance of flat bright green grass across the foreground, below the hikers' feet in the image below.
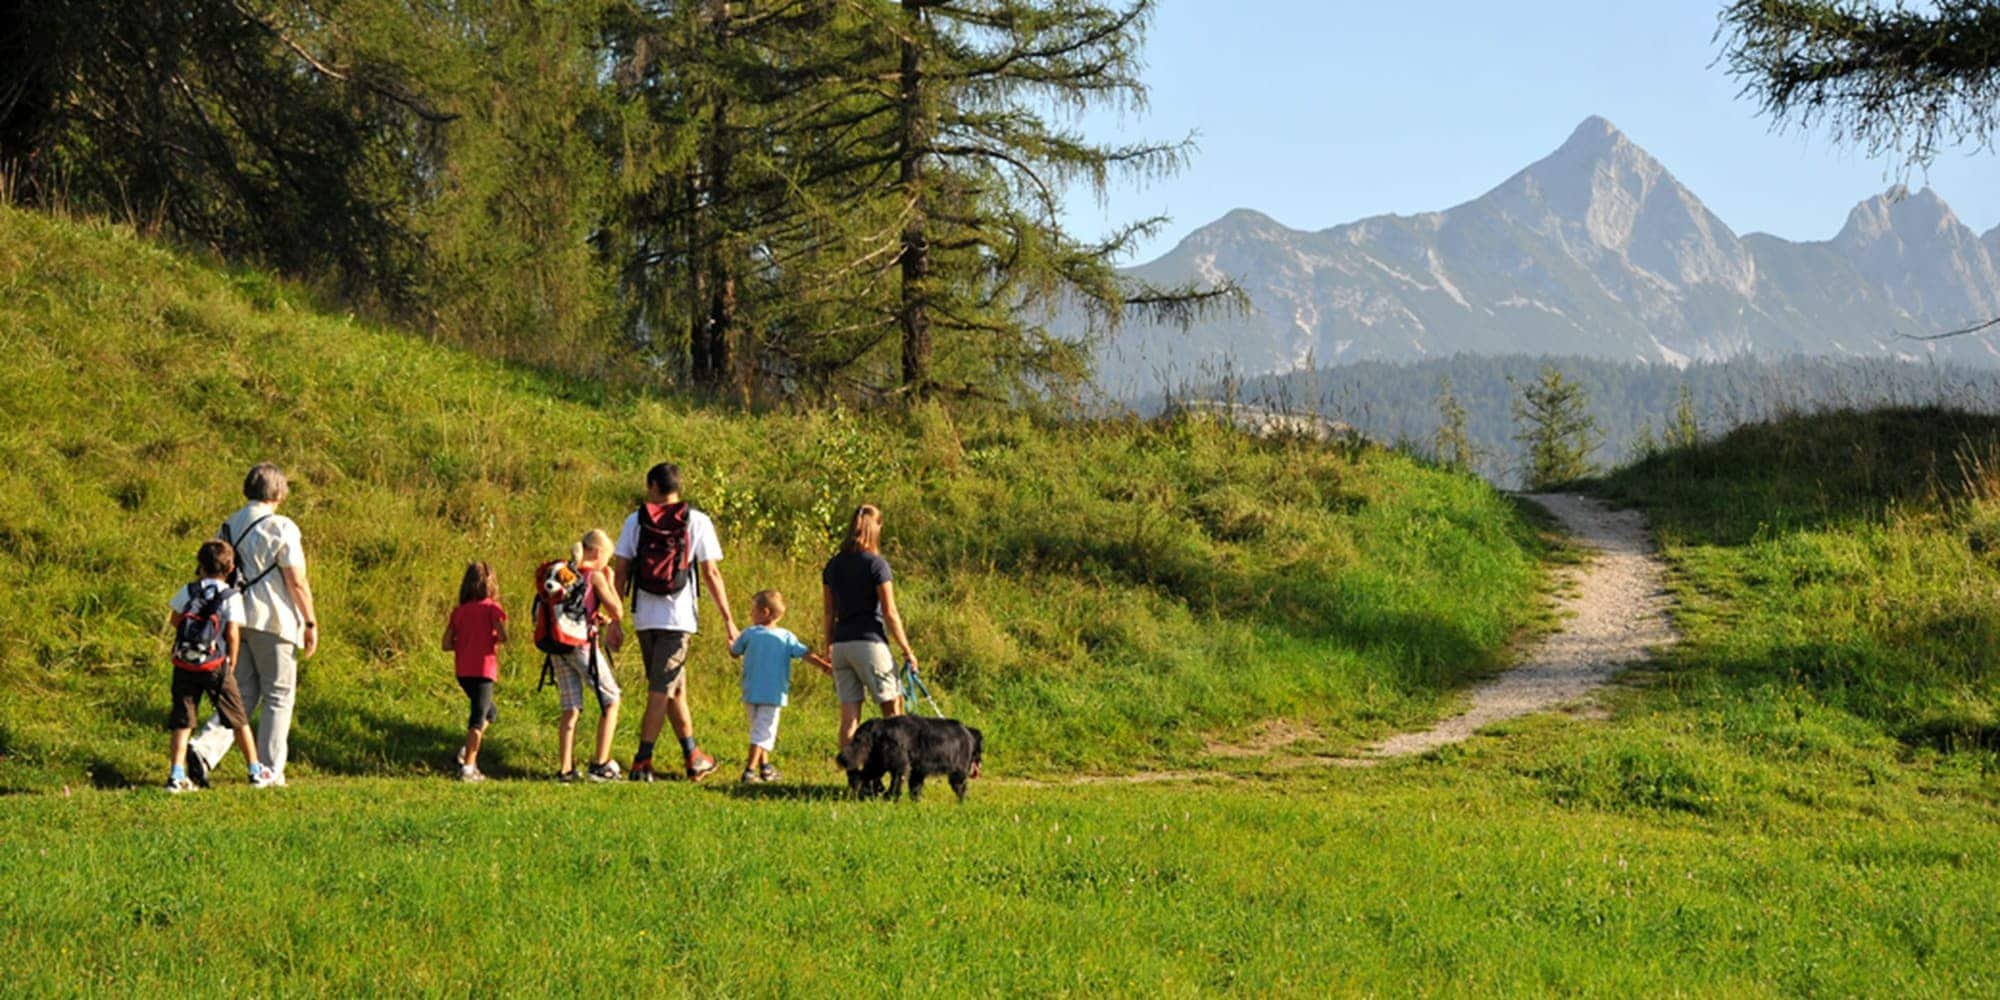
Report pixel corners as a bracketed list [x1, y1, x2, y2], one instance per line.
[0, 748, 2000, 996]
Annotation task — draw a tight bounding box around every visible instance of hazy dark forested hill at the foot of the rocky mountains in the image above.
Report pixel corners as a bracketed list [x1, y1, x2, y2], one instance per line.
[1184, 354, 2000, 484]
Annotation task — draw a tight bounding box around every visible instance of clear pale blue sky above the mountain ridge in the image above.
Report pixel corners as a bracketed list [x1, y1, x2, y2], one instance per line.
[1070, 0, 2000, 260]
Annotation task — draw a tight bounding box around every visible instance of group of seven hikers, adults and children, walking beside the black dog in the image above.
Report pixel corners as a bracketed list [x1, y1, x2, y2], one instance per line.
[166, 462, 916, 792]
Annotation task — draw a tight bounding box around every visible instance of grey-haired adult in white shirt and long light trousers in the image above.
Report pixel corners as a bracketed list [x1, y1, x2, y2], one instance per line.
[188, 462, 320, 786]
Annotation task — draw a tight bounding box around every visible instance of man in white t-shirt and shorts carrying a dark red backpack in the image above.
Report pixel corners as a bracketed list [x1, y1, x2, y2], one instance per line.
[612, 462, 738, 782]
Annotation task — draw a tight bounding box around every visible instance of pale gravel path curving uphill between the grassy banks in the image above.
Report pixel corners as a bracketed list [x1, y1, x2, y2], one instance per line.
[1350, 494, 1674, 764]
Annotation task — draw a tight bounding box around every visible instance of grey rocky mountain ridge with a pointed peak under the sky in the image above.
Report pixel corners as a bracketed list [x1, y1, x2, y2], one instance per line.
[1100, 118, 2000, 396]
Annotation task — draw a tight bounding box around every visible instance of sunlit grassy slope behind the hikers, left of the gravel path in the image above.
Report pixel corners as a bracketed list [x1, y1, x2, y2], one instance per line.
[0, 212, 1540, 788]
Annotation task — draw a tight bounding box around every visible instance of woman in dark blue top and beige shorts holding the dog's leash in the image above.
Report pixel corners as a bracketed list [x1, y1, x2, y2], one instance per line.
[820, 504, 916, 750]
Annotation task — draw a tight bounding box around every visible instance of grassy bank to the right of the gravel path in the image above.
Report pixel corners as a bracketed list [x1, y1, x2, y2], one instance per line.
[1606, 408, 2000, 756]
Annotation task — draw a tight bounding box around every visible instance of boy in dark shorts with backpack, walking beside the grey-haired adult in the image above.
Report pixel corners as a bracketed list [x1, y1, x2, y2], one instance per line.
[166, 538, 274, 794]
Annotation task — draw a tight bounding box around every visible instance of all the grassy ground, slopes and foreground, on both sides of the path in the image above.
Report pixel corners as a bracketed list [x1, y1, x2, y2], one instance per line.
[11, 210, 2000, 996]
